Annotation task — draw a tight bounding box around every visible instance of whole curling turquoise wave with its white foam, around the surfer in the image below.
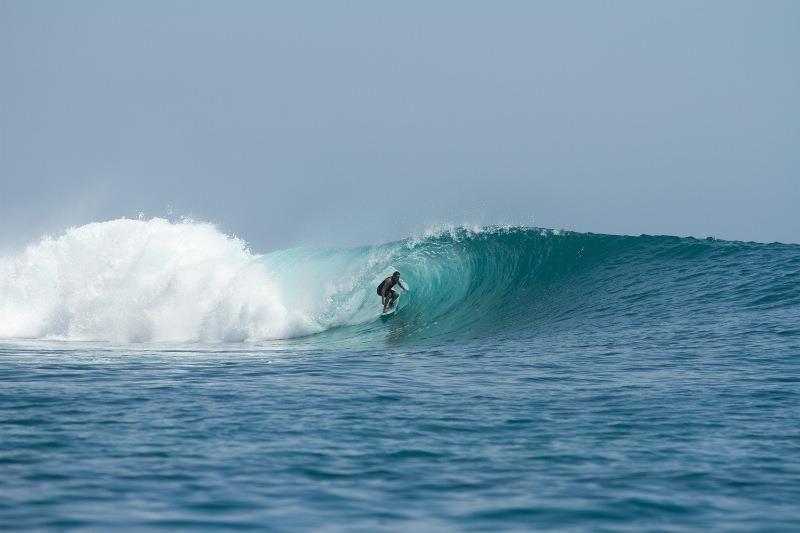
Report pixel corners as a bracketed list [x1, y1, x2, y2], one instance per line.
[0, 219, 800, 345]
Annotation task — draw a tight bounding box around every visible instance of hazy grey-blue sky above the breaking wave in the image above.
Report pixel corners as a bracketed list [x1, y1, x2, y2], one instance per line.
[0, 0, 800, 251]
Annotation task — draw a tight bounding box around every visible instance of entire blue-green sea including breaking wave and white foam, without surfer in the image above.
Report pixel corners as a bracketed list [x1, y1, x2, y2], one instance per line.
[0, 219, 800, 531]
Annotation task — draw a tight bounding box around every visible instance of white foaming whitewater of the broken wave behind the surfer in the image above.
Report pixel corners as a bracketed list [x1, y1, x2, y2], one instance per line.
[0, 218, 388, 342]
